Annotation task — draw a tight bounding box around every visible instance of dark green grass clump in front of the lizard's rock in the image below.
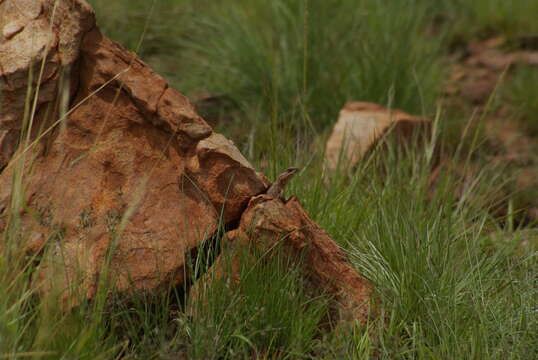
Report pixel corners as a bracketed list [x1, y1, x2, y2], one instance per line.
[182, 249, 327, 359]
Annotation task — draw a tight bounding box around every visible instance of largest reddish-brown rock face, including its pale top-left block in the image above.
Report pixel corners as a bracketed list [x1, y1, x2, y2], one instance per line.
[0, 0, 267, 304]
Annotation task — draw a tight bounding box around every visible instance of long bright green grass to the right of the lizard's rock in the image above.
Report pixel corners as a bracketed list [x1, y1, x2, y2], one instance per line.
[293, 131, 538, 359]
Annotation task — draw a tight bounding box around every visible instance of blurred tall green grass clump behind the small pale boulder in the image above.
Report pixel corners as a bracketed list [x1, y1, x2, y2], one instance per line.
[180, 0, 441, 146]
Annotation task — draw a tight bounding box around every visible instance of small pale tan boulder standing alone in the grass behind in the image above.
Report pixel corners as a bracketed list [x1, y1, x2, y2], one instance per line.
[325, 102, 429, 171]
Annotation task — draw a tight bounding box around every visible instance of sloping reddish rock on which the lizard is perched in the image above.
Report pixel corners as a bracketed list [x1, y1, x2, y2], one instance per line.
[191, 195, 372, 324]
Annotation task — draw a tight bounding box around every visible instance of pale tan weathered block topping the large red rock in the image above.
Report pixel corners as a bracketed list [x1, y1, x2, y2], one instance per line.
[0, 0, 95, 169]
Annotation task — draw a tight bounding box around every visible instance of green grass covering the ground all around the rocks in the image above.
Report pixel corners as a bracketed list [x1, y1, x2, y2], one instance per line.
[0, 0, 538, 359]
